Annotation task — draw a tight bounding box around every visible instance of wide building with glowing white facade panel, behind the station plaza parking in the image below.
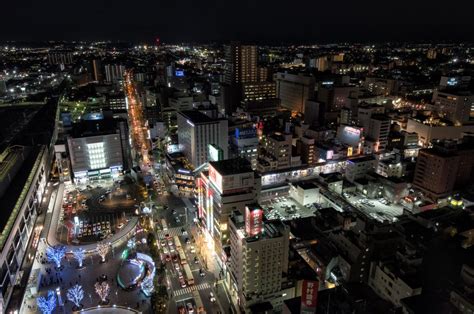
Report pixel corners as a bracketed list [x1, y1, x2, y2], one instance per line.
[67, 118, 131, 183]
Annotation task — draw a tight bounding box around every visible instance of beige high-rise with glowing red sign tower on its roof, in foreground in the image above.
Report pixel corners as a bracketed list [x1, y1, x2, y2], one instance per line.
[229, 209, 289, 313]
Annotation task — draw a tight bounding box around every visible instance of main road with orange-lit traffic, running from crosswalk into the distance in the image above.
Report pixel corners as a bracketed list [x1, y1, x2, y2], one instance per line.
[125, 71, 229, 313]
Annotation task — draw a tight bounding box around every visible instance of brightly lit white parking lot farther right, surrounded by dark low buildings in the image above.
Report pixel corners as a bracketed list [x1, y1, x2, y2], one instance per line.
[343, 193, 403, 222]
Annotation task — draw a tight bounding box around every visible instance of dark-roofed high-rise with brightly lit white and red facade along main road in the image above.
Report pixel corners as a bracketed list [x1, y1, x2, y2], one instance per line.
[197, 158, 261, 262]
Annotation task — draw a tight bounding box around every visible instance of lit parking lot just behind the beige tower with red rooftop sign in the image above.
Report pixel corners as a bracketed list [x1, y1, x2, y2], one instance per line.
[262, 196, 316, 220]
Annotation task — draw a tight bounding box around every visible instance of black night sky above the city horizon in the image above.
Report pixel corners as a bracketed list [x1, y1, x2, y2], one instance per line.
[0, 0, 474, 43]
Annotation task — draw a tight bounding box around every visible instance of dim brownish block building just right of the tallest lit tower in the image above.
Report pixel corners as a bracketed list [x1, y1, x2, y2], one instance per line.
[274, 73, 315, 113]
